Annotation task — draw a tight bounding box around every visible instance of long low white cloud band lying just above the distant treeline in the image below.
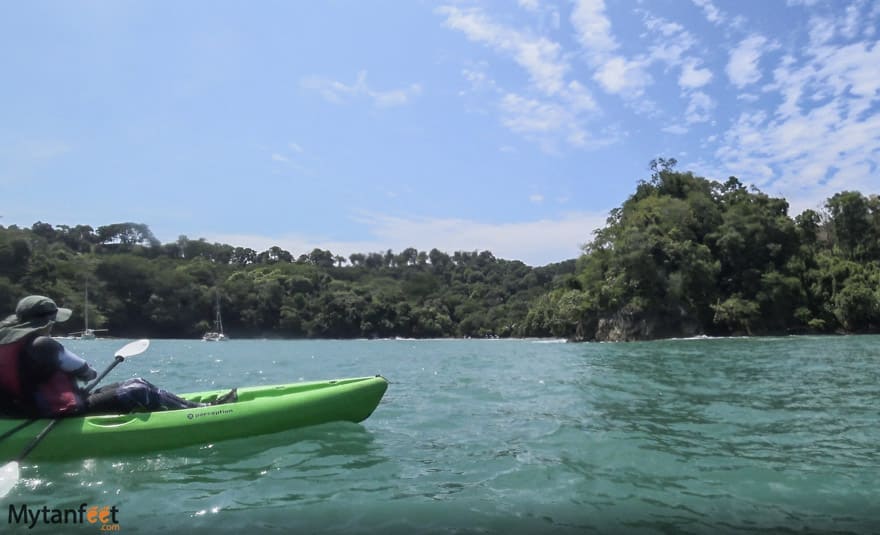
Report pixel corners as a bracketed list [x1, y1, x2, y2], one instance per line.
[205, 212, 607, 266]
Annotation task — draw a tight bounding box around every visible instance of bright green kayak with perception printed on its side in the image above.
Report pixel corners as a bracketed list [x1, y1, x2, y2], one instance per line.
[0, 376, 388, 462]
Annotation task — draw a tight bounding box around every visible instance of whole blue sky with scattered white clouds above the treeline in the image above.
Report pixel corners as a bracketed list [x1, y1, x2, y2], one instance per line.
[0, 0, 880, 265]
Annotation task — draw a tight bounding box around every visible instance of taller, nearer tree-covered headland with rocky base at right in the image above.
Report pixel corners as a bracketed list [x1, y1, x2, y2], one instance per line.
[523, 159, 880, 340]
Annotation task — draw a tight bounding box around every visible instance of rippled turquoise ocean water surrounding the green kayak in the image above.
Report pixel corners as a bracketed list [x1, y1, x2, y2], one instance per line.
[0, 336, 880, 534]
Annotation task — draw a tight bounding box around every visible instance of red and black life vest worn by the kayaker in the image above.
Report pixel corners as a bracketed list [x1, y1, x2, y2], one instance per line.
[0, 337, 84, 417]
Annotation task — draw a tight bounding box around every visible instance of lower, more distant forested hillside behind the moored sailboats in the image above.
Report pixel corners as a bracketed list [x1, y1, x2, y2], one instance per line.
[0, 223, 575, 338]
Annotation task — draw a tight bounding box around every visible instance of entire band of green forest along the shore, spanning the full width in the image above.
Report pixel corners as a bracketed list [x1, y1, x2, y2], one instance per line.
[0, 158, 880, 341]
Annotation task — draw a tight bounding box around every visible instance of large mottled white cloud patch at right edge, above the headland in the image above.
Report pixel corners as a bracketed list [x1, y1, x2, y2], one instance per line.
[716, 33, 880, 217]
